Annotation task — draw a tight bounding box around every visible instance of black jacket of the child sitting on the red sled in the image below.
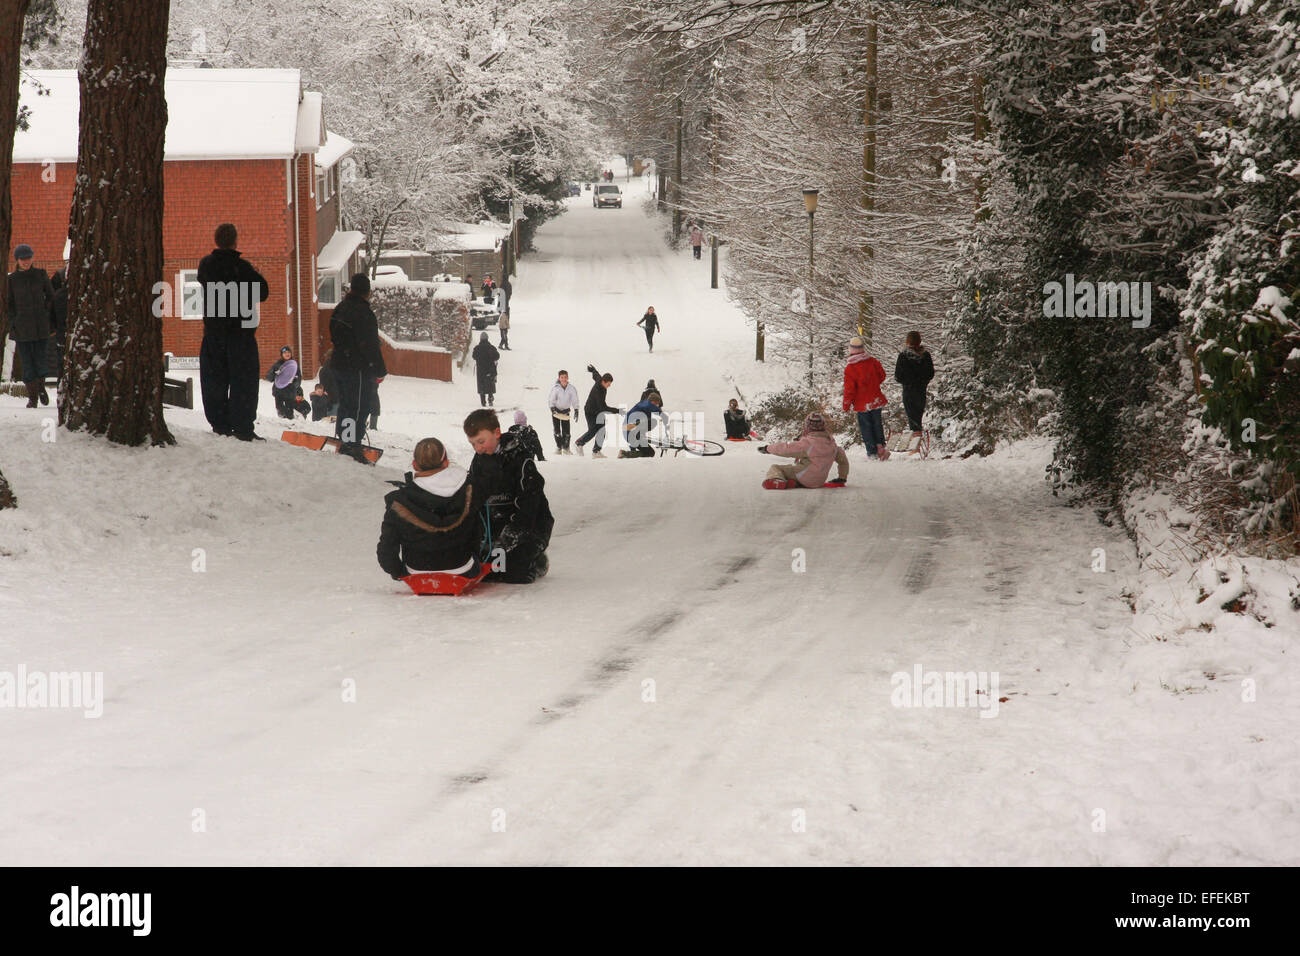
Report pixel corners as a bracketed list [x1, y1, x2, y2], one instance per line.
[376, 471, 482, 579]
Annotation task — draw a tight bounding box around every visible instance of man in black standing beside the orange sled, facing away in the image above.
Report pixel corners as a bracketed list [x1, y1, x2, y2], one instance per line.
[329, 272, 389, 464]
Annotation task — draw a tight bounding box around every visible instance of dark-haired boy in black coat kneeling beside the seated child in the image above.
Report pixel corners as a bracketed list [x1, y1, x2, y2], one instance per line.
[464, 408, 555, 584]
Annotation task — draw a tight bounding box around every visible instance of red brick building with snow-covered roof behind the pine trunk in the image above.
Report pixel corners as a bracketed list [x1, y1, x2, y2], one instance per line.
[7, 69, 363, 376]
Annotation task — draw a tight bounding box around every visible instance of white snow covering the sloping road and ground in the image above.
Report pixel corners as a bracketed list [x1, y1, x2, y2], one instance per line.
[0, 174, 1300, 865]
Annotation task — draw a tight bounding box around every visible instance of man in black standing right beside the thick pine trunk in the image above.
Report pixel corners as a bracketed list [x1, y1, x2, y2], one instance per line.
[199, 222, 270, 441]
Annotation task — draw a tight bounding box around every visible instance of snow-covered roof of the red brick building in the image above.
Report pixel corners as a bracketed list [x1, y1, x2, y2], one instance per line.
[13, 69, 325, 163]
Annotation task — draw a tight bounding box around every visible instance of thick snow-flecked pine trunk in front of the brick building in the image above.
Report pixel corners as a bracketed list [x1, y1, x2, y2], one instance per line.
[59, 0, 174, 445]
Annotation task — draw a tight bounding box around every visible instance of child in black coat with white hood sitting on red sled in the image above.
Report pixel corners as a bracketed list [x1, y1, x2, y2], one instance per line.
[376, 438, 482, 580]
